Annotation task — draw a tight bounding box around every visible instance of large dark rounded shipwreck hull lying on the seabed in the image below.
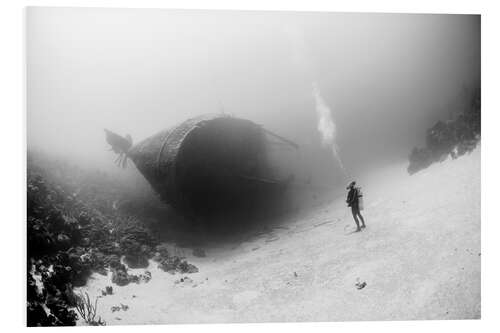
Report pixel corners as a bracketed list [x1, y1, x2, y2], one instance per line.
[127, 115, 286, 216]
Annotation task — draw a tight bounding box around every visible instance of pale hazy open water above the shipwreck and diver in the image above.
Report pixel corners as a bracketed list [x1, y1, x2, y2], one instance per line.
[26, 7, 480, 185]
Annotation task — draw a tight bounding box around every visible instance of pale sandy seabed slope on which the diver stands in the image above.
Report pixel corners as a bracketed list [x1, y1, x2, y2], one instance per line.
[79, 148, 481, 324]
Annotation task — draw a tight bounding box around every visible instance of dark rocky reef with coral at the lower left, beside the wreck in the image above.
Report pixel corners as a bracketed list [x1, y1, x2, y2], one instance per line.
[27, 152, 197, 326]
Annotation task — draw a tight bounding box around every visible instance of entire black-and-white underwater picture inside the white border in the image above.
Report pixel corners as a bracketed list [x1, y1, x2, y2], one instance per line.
[26, 7, 481, 326]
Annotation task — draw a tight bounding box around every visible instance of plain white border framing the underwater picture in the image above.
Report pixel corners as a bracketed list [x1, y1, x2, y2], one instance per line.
[0, 0, 500, 333]
